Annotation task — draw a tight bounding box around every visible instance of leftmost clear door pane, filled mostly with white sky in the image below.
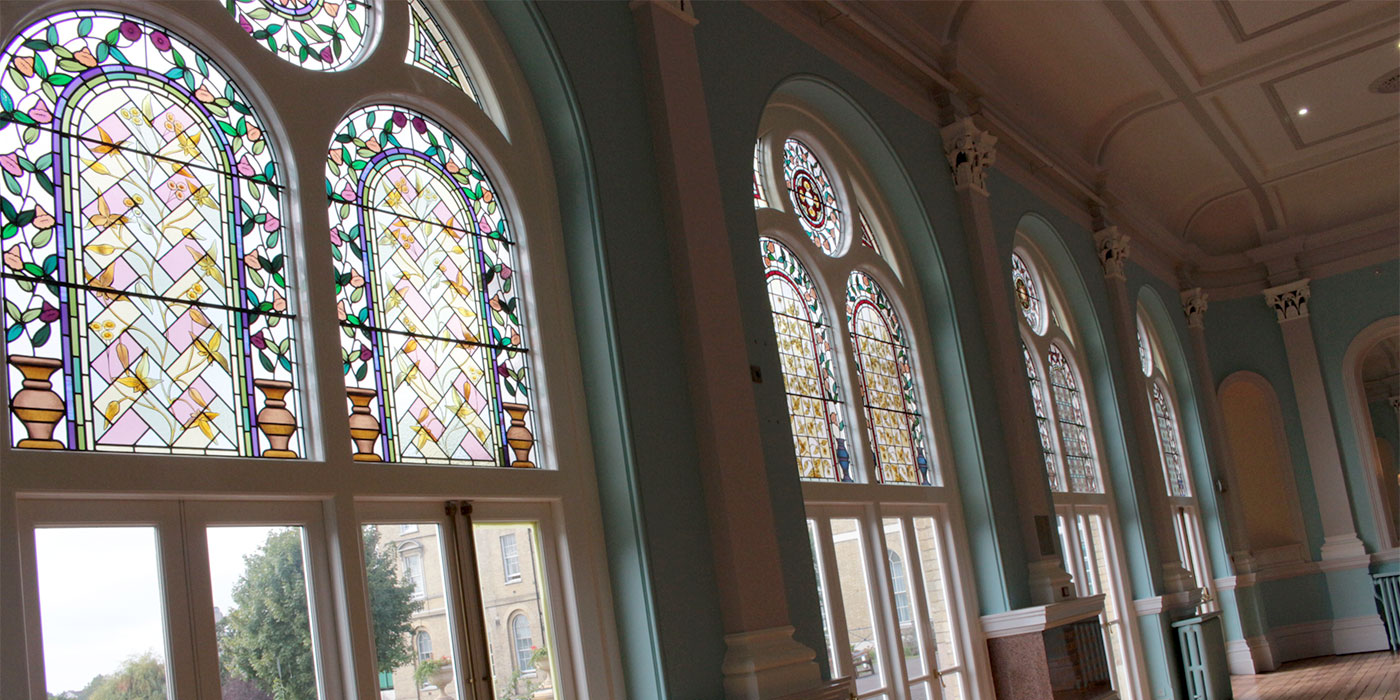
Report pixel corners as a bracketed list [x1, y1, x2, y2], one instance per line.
[34, 528, 168, 699]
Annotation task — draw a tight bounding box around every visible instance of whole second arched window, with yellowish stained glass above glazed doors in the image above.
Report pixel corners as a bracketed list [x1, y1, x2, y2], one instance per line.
[753, 102, 973, 697]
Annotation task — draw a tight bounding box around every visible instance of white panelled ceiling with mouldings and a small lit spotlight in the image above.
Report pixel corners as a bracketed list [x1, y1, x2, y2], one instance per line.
[755, 0, 1400, 286]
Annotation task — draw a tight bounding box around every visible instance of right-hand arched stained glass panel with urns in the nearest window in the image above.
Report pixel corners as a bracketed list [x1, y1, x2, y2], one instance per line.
[326, 105, 533, 466]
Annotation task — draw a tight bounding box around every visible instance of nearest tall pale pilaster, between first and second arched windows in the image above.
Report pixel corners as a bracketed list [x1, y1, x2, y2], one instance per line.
[631, 0, 822, 700]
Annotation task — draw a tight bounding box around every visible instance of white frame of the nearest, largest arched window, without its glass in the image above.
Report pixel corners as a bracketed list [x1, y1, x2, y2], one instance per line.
[0, 0, 623, 700]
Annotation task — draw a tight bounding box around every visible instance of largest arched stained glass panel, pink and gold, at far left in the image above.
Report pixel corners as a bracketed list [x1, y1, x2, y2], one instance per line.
[0, 11, 301, 456]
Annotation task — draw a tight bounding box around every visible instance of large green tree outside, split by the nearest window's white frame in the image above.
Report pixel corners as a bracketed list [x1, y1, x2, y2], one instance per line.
[218, 526, 421, 700]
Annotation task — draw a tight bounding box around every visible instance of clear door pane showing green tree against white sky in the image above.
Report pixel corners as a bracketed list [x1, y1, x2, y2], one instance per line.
[207, 525, 319, 700]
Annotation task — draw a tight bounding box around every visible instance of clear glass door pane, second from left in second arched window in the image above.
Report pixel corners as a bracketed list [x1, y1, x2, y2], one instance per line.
[832, 519, 885, 694]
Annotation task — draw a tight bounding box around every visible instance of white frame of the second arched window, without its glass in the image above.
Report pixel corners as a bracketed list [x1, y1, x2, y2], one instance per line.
[753, 95, 991, 700]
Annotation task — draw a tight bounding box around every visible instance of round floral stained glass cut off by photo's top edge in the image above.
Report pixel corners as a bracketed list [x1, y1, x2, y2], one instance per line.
[220, 0, 371, 70]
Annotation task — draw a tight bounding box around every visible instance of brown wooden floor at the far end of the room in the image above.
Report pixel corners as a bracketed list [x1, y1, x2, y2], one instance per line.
[1231, 651, 1400, 700]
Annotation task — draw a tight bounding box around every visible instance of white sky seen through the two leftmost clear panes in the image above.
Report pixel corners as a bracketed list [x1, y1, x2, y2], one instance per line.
[34, 526, 280, 693]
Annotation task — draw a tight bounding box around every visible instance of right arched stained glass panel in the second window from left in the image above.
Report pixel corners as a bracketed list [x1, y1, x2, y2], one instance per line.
[846, 270, 932, 486]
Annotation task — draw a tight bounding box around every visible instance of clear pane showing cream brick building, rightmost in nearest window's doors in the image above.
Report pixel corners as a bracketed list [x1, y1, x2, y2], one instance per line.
[472, 522, 559, 700]
